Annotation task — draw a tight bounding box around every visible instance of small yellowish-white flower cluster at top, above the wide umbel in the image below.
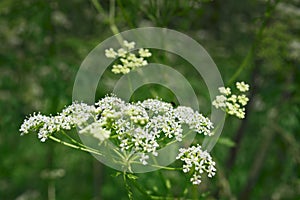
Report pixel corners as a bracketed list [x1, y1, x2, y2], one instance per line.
[105, 40, 152, 74]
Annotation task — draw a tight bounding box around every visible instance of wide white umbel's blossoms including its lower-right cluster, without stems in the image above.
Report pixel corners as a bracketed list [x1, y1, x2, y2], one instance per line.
[20, 96, 215, 184]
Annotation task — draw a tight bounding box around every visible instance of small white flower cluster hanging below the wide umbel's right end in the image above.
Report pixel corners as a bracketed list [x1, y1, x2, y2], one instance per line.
[176, 145, 216, 184]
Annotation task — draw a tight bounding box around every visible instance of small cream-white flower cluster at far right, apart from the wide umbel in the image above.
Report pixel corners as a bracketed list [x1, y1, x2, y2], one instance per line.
[212, 82, 249, 119]
